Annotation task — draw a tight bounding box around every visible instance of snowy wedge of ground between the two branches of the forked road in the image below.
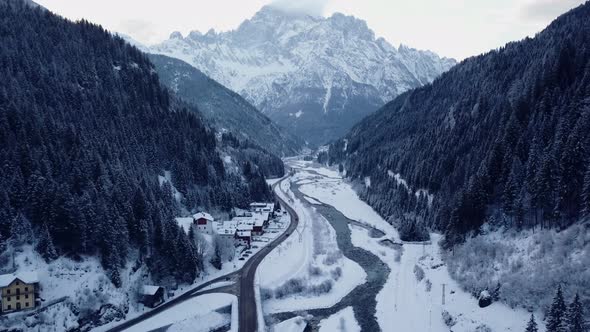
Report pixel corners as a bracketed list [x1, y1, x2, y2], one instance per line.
[125, 293, 238, 332]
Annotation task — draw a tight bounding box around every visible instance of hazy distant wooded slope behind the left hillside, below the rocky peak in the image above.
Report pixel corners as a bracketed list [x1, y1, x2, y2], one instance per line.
[150, 55, 304, 156]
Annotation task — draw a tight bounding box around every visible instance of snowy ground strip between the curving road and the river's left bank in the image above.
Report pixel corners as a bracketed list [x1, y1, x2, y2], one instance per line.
[256, 176, 366, 315]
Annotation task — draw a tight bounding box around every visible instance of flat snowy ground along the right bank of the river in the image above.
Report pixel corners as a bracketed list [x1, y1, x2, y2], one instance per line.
[289, 161, 530, 332]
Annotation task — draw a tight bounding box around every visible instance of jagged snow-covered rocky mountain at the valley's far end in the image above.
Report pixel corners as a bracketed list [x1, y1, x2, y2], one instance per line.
[149, 6, 456, 144]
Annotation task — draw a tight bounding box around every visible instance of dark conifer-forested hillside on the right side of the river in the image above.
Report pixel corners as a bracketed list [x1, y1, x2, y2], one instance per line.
[328, 3, 590, 244]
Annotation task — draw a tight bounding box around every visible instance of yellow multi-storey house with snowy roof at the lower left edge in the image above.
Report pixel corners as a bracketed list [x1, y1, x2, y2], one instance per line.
[0, 272, 39, 313]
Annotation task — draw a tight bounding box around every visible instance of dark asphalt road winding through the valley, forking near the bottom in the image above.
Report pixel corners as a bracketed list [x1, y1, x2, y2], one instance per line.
[107, 176, 299, 332]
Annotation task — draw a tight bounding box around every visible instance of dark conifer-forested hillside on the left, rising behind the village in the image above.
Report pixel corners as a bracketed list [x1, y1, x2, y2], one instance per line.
[0, 1, 270, 285]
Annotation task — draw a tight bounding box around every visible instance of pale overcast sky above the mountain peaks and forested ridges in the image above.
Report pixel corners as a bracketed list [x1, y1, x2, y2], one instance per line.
[36, 0, 584, 60]
